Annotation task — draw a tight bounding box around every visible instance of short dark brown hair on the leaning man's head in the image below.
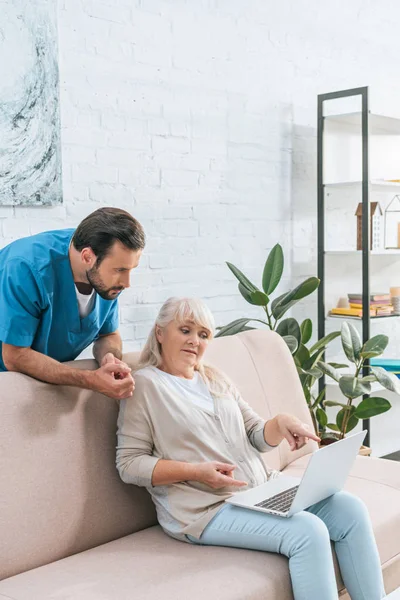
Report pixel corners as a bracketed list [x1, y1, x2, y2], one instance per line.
[72, 207, 146, 266]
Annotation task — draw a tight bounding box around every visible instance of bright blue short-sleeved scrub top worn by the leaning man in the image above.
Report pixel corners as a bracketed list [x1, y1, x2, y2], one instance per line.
[0, 229, 118, 371]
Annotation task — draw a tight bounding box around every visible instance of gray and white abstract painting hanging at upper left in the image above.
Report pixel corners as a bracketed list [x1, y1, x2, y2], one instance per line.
[0, 0, 62, 206]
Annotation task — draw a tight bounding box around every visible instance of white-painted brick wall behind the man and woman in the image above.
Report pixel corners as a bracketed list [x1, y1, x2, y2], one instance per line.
[0, 0, 400, 356]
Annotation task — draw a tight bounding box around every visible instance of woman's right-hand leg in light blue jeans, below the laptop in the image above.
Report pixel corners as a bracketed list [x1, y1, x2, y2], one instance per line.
[308, 492, 385, 600]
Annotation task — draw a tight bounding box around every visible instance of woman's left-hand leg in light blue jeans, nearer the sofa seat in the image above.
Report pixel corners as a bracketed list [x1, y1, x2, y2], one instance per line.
[188, 505, 338, 600]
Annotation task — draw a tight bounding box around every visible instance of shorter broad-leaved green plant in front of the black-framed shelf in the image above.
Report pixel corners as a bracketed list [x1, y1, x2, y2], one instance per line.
[318, 322, 400, 443]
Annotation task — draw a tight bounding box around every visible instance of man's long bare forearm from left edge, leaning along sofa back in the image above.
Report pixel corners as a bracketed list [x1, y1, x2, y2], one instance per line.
[2, 343, 134, 400]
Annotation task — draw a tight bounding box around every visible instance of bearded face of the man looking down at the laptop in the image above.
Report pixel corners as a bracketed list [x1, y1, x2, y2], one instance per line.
[86, 241, 142, 300]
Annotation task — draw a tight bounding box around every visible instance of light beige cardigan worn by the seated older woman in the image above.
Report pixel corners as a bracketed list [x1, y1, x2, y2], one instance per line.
[117, 367, 273, 541]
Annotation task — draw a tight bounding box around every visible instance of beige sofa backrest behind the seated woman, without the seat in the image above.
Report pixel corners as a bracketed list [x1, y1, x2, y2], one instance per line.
[0, 331, 313, 579]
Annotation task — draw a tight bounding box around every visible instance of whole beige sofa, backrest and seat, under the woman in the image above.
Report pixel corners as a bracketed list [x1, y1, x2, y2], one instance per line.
[0, 331, 400, 600]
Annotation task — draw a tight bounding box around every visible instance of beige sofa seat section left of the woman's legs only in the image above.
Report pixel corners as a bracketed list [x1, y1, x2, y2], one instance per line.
[0, 526, 293, 600]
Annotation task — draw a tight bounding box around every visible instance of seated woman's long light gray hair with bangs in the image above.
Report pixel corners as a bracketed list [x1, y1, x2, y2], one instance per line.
[139, 298, 233, 396]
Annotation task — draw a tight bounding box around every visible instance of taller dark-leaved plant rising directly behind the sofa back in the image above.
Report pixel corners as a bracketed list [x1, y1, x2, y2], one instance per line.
[216, 244, 340, 434]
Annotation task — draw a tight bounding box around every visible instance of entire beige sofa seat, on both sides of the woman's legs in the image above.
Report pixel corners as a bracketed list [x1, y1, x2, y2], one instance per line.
[0, 457, 400, 600]
